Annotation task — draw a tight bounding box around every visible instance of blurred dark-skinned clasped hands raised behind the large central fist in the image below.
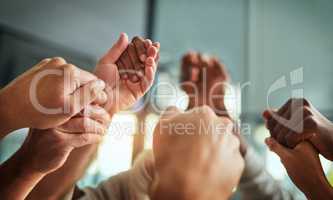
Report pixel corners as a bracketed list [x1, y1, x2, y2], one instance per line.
[181, 52, 248, 156]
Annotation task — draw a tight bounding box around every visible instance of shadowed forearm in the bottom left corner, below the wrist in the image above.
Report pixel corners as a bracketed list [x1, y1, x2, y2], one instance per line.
[0, 146, 44, 200]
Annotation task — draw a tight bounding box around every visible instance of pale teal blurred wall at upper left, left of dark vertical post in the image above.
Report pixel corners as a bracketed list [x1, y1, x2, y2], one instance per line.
[0, 0, 146, 58]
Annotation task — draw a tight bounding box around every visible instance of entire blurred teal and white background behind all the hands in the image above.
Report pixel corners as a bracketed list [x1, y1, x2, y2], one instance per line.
[0, 0, 333, 198]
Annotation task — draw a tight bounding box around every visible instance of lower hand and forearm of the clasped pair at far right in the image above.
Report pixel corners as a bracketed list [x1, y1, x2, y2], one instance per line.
[265, 138, 333, 200]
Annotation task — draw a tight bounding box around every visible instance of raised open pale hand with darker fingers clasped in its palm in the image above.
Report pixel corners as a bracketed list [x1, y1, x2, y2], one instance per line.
[95, 34, 159, 114]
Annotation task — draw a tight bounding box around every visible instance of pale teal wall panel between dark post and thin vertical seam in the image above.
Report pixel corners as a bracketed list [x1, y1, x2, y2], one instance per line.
[154, 0, 248, 81]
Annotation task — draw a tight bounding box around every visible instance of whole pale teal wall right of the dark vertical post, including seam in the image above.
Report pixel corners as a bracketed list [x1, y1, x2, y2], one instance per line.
[155, 0, 333, 115]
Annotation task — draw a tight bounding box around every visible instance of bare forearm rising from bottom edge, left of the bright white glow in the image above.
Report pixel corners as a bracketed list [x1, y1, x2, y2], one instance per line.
[27, 144, 98, 200]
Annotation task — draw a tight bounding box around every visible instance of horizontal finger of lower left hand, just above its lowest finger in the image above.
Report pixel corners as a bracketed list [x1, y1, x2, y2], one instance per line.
[57, 117, 106, 135]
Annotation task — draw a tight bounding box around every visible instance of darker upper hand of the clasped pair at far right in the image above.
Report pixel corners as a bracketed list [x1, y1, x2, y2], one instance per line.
[263, 99, 333, 160]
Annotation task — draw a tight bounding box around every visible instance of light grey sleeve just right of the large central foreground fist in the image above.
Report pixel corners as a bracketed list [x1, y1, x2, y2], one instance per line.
[238, 148, 296, 200]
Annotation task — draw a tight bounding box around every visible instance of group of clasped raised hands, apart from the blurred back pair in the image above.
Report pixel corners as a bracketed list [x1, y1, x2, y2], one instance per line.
[0, 34, 333, 199]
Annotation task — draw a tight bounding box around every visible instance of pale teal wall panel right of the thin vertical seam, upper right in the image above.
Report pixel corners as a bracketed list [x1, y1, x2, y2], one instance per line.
[247, 0, 333, 113]
